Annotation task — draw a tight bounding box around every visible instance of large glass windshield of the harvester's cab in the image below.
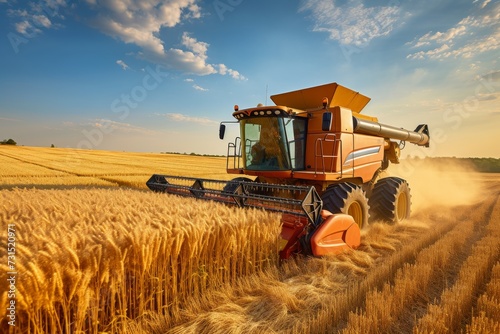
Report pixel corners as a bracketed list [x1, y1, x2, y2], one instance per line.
[240, 117, 306, 170]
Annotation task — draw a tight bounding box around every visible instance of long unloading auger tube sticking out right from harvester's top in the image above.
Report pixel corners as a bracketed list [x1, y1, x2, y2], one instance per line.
[352, 116, 430, 147]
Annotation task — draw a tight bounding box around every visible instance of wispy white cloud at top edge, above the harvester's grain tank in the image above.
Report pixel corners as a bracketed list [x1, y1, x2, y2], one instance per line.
[299, 0, 400, 46]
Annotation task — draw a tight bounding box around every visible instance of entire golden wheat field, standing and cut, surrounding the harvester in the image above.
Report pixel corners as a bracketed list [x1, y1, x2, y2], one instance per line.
[0, 146, 500, 333]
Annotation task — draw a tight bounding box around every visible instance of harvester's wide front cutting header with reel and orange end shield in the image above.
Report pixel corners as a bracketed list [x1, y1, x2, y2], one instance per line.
[146, 174, 361, 259]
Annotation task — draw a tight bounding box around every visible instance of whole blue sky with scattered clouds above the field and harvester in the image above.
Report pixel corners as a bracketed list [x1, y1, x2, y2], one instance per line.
[0, 0, 500, 158]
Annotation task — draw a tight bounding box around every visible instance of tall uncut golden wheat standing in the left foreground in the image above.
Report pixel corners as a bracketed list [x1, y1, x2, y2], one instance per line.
[0, 190, 280, 333]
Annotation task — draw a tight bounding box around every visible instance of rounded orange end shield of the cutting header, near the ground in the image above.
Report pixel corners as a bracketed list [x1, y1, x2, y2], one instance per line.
[311, 214, 361, 256]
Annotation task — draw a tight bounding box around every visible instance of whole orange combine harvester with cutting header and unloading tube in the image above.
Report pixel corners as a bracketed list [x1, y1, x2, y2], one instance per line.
[147, 83, 429, 259]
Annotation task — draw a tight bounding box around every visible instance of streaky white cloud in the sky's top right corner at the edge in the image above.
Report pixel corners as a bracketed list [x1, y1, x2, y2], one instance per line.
[407, 2, 500, 59]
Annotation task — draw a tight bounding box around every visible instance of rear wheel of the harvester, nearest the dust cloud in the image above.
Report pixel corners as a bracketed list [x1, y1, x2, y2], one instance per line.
[369, 177, 411, 223]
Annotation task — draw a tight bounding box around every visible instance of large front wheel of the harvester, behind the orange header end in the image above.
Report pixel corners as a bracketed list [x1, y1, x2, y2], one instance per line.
[321, 182, 370, 229]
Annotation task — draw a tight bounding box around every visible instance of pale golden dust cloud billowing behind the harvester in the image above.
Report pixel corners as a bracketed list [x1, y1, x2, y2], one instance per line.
[387, 159, 484, 213]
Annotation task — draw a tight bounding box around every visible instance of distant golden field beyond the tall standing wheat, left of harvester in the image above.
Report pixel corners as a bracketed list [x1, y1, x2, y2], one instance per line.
[0, 145, 232, 189]
